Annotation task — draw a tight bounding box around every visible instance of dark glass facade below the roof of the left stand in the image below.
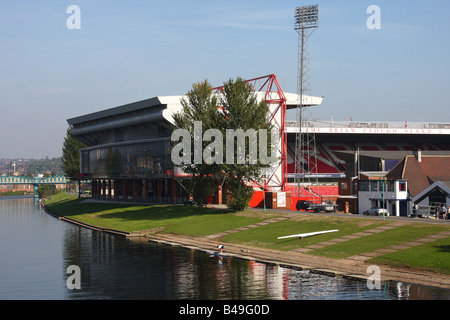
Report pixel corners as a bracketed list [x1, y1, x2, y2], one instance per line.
[81, 138, 189, 203]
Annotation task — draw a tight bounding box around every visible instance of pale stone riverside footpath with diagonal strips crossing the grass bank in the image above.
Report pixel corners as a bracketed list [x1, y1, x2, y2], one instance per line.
[147, 209, 450, 289]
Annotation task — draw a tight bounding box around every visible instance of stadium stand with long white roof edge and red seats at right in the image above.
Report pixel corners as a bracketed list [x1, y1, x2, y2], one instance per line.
[286, 121, 450, 211]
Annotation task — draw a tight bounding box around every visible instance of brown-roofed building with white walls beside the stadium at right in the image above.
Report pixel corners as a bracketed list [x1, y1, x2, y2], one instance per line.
[358, 150, 450, 216]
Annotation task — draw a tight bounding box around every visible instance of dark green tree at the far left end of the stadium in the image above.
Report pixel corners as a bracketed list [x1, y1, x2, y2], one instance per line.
[61, 127, 86, 186]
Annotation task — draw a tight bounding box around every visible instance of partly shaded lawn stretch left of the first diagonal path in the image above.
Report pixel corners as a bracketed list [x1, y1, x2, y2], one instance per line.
[46, 194, 274, 236]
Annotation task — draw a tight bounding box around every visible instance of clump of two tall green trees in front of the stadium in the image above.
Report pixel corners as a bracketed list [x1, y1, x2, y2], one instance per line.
[172, 78, 271, 211]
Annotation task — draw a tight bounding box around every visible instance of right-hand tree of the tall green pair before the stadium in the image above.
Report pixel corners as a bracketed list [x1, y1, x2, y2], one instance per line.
[220, 78, 272, 211]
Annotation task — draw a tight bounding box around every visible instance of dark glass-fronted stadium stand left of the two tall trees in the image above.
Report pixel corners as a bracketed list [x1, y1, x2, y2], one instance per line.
[67, 96, 193, 203]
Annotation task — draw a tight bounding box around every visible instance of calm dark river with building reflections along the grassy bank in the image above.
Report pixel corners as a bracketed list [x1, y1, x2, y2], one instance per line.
[0, 198, 450, 300]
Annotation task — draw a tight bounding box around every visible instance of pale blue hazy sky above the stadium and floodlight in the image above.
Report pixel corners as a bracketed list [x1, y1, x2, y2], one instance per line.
[0, 0, 450, 158]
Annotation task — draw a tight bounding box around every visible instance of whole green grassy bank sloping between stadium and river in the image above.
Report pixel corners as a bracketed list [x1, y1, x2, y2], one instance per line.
[46, 194, 450, 274]
